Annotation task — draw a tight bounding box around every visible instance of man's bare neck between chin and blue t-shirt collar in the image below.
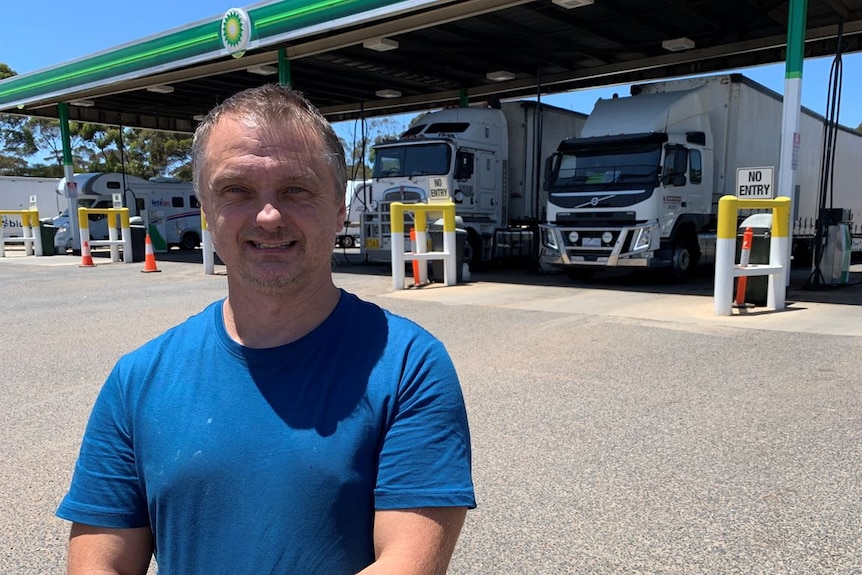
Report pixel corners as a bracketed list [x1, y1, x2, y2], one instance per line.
[222, 284, 341, 348]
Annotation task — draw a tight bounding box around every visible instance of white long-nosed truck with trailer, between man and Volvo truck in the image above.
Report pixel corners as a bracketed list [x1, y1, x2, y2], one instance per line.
[360, 101, 586, 266]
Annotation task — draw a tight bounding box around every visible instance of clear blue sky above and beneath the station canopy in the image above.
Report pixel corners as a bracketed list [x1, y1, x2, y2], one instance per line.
[0, 0, 862, 137]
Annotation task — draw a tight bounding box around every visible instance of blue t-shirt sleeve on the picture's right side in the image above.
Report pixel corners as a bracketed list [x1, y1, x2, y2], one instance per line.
[374, 336, 476, 510]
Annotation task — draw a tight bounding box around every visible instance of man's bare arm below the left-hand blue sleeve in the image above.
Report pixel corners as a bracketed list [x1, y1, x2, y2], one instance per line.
[66, 523, 153, 575]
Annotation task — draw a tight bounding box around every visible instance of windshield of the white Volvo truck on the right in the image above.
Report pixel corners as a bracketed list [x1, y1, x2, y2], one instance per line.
[551, 145, 661, 189]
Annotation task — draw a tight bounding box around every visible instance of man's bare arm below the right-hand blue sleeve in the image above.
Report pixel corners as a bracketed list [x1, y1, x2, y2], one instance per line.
[359, 507, 467, 575]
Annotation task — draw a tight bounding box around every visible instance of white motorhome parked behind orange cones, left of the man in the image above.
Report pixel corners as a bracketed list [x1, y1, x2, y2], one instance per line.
[54, 173, 203, 253]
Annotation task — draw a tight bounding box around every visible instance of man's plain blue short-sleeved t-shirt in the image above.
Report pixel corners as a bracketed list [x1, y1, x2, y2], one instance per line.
[57, 292, 475, 575]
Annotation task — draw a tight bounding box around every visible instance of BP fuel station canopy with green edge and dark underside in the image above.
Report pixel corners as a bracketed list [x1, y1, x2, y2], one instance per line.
[0, 0, 862, 131]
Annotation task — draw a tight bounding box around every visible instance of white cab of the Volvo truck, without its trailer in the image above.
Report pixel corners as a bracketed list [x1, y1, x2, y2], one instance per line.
[540, 86, 714, 279]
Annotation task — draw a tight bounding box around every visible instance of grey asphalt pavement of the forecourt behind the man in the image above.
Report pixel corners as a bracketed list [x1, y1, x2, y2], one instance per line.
[0, 253, 862, 575]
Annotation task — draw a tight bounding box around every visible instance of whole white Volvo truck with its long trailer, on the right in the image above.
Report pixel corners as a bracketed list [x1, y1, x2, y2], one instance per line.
[540, 74, 862, 279]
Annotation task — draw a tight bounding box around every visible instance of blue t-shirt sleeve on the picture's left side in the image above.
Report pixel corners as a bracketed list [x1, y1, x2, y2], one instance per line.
[57, 367, 150, 529]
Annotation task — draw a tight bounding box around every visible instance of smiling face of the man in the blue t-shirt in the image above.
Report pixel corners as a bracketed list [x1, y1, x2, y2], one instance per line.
[200, 116, 345, 300]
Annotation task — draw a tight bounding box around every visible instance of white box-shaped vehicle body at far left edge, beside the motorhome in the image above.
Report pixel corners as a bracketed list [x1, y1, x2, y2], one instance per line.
[0, 176, 66, 238]
